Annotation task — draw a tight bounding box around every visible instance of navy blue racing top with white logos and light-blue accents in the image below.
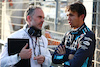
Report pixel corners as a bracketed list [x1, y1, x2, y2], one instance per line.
[52, 23, 96, 67]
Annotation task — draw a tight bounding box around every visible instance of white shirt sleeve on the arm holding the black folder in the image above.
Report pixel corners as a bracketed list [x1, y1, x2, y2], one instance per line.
[0, 44, 21, 67]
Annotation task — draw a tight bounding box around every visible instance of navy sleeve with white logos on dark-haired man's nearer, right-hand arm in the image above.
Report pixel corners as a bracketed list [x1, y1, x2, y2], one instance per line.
[64, 31, 95, 67]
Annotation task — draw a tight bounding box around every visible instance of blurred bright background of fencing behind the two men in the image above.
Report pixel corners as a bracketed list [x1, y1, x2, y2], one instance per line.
[0, 0, 100, 67]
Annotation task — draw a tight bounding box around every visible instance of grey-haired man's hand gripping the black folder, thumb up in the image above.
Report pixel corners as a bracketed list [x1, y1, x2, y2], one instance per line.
[19, 44, 32, 59]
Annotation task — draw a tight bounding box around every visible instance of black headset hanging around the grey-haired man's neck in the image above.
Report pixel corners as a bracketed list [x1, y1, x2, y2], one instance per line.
[28, 26, 42, 37]
